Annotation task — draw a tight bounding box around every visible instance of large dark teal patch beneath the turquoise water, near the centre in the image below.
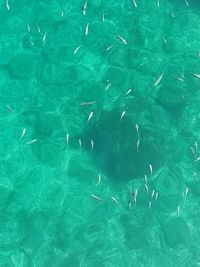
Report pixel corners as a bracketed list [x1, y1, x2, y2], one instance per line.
[76, 111, 164, 182]
